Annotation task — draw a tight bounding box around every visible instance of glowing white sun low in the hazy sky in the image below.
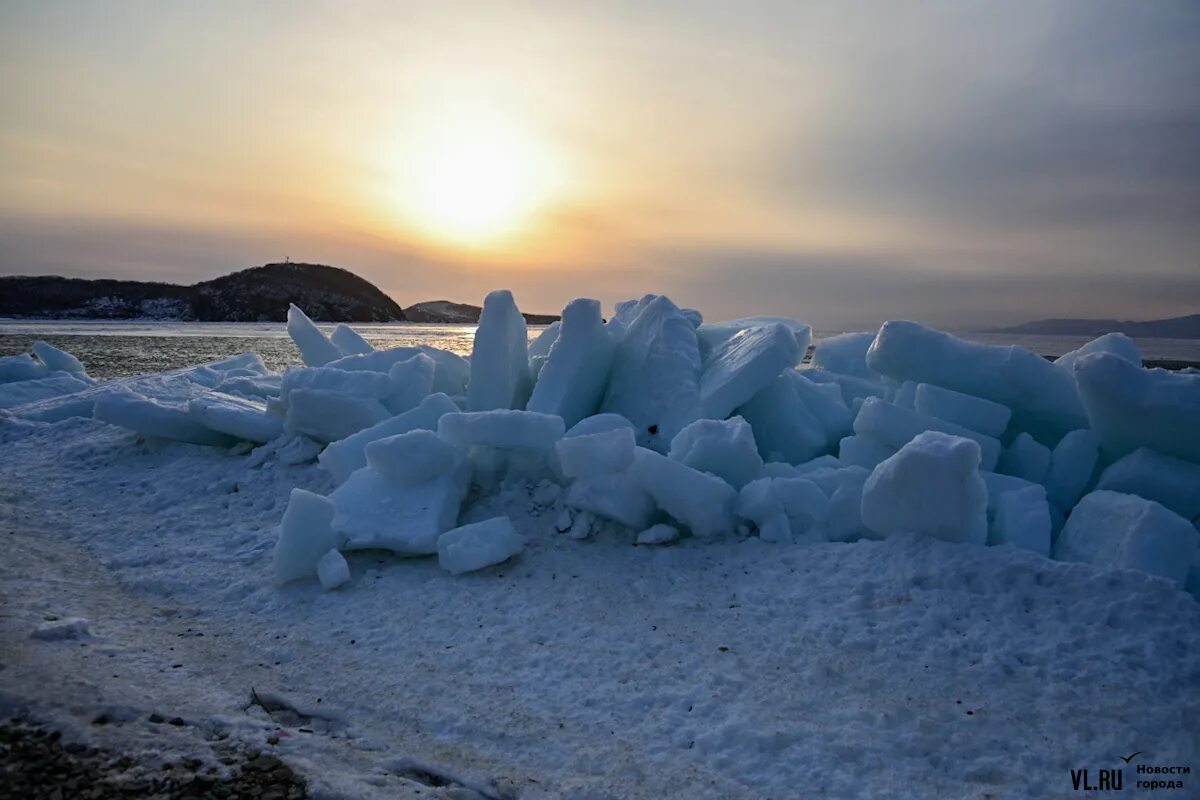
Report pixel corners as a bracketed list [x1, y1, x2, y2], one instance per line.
[400, 113, 557, 247]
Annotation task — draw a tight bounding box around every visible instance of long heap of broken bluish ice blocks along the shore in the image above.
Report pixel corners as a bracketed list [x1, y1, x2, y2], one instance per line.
[0, 291, 1200, 593]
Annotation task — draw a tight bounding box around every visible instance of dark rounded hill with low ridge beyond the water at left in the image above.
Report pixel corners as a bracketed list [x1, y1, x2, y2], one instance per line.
[0, 263, 407, 323]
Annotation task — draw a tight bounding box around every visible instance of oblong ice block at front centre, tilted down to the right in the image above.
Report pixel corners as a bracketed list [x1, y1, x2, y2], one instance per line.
[629, 447, 738, 537]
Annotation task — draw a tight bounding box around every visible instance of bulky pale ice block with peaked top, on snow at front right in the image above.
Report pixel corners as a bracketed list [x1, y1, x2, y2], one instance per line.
[863, 431, 988, 545]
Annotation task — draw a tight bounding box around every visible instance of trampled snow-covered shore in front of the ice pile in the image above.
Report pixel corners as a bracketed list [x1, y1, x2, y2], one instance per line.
[0, 420, 1200, 798]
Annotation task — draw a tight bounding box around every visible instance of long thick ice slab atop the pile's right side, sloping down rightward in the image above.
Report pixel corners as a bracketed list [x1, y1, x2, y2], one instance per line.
[866, 321, 1087, 445]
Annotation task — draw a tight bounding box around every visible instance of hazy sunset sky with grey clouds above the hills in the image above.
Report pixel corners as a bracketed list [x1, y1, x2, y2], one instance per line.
[0, 0, 1200, 330]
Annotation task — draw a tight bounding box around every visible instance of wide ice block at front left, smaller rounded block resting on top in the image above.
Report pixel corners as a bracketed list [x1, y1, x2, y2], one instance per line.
[329, 463, 470, 555]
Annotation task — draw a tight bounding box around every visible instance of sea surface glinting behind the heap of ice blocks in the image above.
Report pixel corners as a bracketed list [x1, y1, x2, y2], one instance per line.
[0, 319, 1200, 378]
